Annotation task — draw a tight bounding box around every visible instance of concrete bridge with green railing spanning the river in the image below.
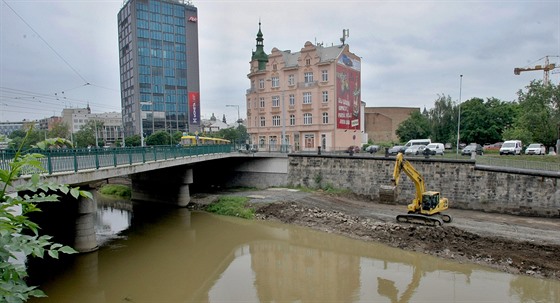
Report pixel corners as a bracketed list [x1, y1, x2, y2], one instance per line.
[5, 145, 288, 252]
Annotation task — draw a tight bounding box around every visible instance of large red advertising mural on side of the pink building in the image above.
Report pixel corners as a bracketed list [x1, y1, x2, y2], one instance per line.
[336, 54, 361, 129]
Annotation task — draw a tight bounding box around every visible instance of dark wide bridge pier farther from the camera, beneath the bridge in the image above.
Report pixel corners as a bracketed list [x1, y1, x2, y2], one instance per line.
[130, 166, 193, 207]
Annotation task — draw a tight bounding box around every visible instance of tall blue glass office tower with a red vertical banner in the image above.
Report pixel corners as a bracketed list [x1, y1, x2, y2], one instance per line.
[117, 0, 200, 138]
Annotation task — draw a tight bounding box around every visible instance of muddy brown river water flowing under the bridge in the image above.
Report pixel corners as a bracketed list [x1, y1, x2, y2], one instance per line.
[30, 196, 560, 303]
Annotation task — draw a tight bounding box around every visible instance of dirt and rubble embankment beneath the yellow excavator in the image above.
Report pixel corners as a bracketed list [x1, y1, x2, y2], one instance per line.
[188, 191, 560, 280]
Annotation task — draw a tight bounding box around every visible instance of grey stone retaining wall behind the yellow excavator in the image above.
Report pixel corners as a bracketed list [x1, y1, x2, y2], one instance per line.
[287, 155, 560, 217]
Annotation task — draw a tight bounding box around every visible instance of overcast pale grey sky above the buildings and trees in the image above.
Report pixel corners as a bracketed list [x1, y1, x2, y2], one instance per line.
[0, 0, 560, 122]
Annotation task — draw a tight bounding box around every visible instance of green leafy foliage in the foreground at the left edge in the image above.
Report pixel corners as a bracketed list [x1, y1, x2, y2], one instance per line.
[0, 130, 92, 302]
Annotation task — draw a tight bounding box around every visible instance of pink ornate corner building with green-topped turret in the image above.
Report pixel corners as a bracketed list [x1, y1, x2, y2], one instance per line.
[246, 23, 363, 151]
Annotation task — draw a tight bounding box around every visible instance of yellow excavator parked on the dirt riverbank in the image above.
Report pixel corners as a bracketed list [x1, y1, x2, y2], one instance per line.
[380, 153, 452, 226]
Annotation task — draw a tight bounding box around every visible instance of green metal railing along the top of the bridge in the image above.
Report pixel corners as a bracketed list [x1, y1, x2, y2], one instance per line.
[0, 145, 234, 174]
